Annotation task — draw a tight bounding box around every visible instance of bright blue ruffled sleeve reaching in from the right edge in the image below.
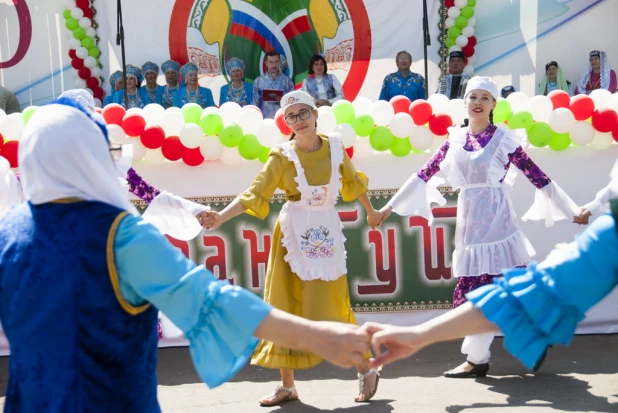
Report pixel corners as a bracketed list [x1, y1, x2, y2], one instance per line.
[466, 215, 618, 368]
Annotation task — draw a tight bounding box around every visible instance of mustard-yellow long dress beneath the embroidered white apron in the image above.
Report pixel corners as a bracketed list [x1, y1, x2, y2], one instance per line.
[238, 136, 368, 370]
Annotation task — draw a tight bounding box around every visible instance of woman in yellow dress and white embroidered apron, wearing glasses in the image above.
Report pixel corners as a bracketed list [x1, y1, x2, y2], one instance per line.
[197, 91, 382, 406]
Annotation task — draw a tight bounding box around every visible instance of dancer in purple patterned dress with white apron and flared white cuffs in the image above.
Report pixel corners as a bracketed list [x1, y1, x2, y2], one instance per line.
[381, 76, 579, 378]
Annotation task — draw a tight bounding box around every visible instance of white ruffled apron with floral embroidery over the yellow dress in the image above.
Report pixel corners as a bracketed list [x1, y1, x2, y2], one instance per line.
[279, 136, 347, 281]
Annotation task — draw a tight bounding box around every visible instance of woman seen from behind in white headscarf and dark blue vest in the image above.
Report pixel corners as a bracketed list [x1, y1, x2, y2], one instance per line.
[0, 98, 369, 413]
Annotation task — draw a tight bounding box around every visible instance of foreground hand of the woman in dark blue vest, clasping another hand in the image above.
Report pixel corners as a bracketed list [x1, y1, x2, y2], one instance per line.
[307, 321, 370, 368]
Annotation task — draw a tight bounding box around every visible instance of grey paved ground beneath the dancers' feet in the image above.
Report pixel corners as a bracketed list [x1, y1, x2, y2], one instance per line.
[0, 335, 618, 413]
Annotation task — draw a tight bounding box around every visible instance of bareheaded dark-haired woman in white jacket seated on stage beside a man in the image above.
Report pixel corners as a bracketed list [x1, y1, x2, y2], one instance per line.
[301, 54, 344, 107]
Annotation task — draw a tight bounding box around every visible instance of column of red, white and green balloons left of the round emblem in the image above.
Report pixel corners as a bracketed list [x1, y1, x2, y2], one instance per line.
[62, 0, 104, 107]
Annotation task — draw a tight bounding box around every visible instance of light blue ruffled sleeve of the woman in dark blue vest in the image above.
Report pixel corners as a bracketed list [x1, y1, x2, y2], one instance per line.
[114, 216, 271, 388]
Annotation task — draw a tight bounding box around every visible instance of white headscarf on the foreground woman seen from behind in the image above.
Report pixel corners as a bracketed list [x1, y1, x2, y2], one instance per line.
[19, 99, 137, 215]
